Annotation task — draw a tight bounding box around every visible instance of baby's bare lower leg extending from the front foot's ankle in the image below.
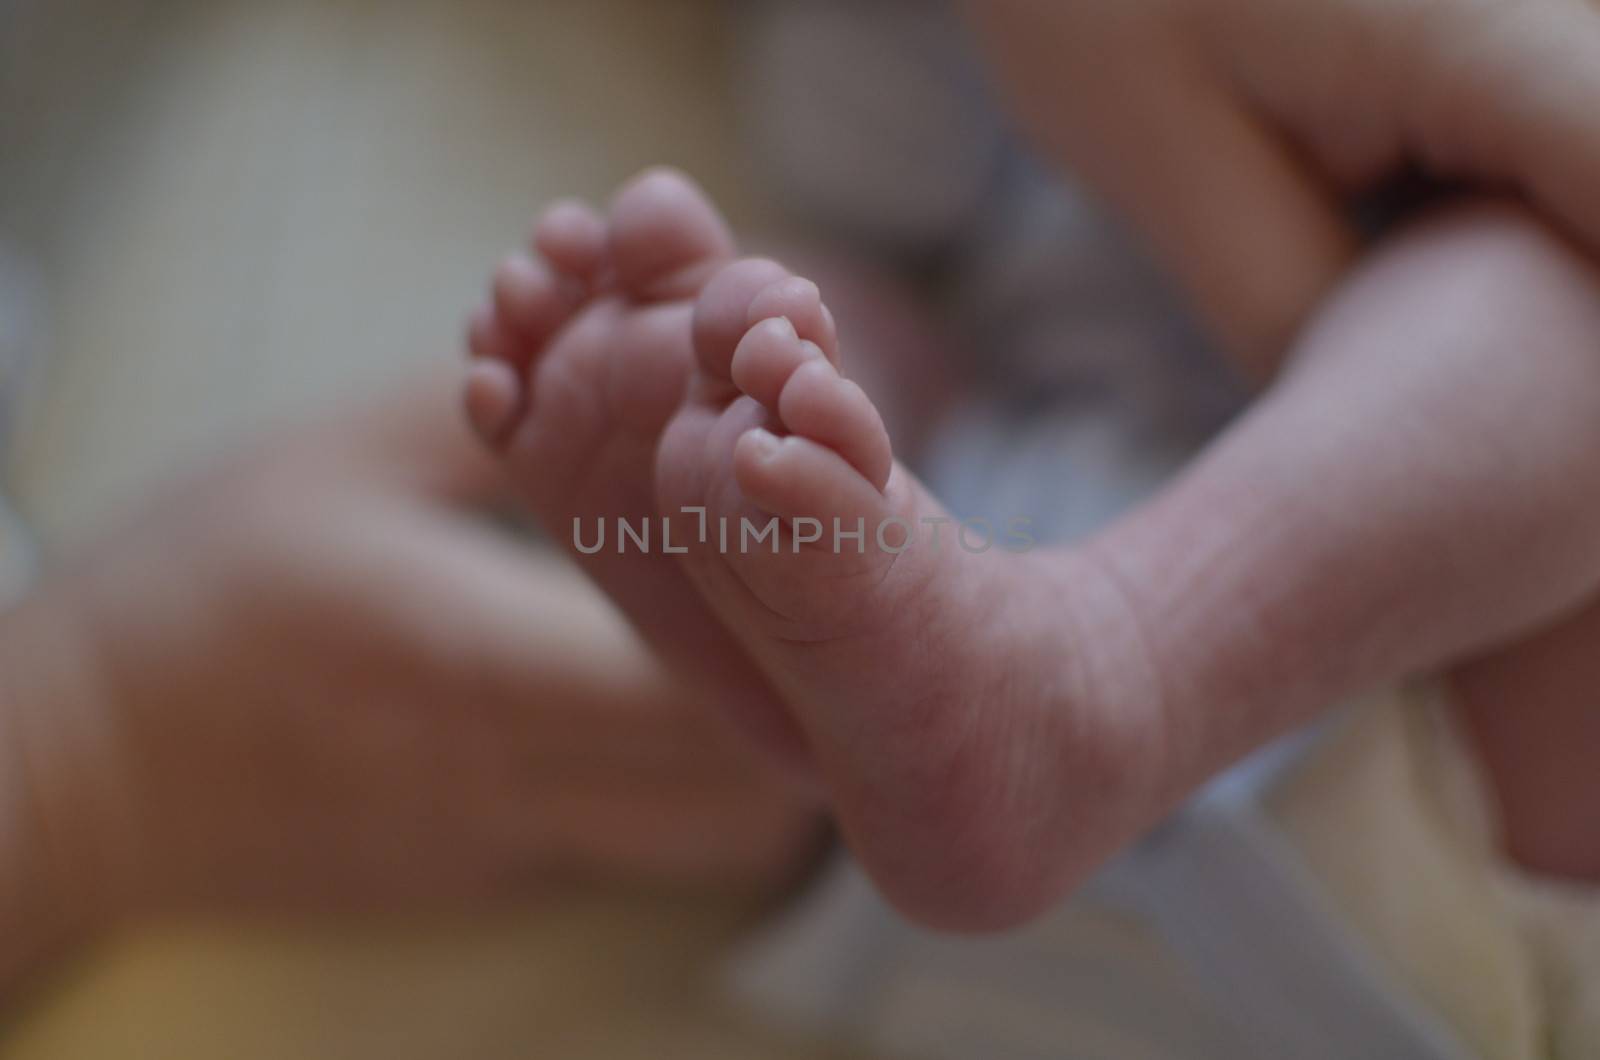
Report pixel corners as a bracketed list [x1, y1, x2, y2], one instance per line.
[1091, 199, 1600, 797]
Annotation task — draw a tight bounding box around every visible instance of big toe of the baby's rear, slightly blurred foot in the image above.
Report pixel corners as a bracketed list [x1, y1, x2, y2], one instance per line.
[610, 170, 733, 301]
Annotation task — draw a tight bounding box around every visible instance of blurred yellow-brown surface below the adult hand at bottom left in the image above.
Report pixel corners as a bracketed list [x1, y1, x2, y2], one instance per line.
[0, 898, 834, 1060]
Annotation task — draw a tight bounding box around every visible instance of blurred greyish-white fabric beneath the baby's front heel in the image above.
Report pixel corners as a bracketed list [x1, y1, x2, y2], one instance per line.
[734, 703, 1484, 1060]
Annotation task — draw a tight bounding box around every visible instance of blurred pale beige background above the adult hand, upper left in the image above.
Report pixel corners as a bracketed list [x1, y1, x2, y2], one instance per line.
[0, 0, 768, 538]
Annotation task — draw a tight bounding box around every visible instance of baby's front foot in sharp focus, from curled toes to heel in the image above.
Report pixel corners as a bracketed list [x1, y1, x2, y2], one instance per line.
[658, 261, 1158, 929]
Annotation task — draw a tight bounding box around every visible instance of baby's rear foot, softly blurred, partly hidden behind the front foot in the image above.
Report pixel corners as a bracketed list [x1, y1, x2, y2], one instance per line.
[466, 170, 800, 757]
